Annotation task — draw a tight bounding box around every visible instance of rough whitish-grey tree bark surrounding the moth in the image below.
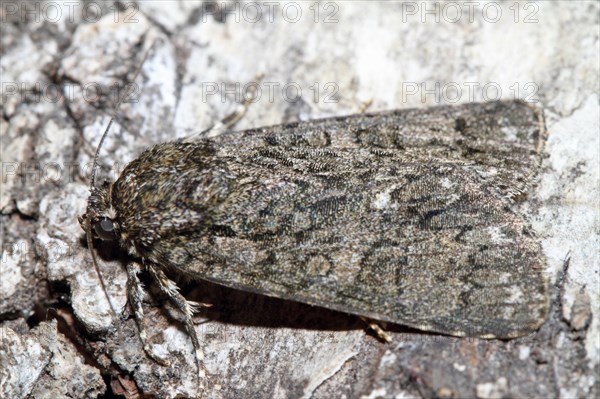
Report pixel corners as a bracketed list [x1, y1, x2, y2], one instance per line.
[0, 1, 600, 398]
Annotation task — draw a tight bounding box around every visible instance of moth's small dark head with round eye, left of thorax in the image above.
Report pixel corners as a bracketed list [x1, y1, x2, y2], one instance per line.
[78, 182, 117, 241]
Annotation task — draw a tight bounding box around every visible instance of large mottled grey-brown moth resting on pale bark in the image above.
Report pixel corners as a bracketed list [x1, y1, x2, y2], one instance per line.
[80, 101, 548, 382]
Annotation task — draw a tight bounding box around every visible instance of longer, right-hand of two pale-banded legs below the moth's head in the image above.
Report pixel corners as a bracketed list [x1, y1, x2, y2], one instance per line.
[148, 266, 211, 380]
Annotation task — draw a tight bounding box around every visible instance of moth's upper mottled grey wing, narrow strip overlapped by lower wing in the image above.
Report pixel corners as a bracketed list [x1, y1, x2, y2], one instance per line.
[214, 101, 547, 200]
